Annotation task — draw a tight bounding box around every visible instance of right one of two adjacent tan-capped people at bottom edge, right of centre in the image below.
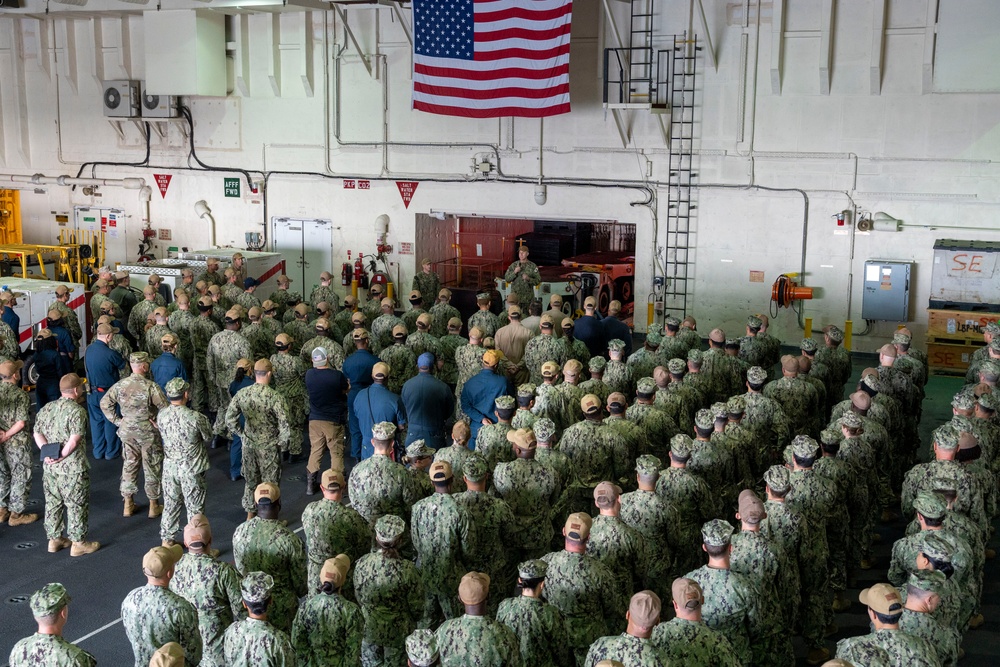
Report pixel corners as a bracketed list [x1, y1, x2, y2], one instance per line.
[651, 578, 743, 667]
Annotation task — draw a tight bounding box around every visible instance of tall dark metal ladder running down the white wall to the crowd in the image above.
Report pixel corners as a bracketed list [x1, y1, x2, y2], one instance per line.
[655, 33, 701, 316]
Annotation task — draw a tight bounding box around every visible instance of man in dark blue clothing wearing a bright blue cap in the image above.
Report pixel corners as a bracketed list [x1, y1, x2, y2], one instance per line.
[400, 352, 455, 449]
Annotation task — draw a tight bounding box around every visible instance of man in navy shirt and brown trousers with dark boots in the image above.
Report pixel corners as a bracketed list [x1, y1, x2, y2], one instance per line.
[306, 347, 350, 496]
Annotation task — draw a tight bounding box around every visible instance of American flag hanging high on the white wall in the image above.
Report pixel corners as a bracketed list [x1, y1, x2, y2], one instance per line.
[413, 0, 573, 118]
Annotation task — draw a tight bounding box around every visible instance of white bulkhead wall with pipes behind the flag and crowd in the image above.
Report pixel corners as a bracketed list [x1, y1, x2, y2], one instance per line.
[0, 0, 1000, 344]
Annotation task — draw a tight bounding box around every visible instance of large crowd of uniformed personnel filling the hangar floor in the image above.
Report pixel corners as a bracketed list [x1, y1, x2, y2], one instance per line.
[0, 250, 1000, 667]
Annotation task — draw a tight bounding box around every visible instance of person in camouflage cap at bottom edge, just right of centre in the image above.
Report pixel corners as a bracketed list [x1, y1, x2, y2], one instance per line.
[496, 560, 573, 667]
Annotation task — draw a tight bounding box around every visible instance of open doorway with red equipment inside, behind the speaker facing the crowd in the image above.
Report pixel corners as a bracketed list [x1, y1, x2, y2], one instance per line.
[414, 211, 636, 319]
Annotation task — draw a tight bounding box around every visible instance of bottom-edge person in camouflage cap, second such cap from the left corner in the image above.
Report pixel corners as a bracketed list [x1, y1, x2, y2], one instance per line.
[223, 572, 296, 667]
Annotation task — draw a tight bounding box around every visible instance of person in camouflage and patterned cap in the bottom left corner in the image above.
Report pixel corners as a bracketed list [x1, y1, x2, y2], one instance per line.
[8, 584, 97, 667]
